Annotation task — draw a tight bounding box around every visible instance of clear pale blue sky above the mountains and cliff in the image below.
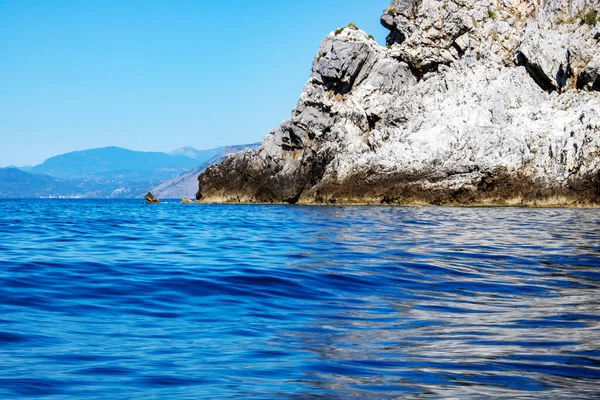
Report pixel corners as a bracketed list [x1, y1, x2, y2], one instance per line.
[0, 0, 389, 167]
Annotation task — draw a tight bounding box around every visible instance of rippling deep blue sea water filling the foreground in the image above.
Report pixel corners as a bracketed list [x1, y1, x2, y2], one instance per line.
[0, 200, 600, 399]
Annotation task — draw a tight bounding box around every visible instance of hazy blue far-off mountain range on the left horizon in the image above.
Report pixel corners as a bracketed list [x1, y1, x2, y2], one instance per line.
[0, 147, 230, 198]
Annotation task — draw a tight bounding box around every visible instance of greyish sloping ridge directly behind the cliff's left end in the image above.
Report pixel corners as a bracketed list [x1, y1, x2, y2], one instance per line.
[151, 143, 260, 199]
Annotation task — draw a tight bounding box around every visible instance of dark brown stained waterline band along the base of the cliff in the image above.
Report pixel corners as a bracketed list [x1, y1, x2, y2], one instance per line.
[196, 172, 600, 208]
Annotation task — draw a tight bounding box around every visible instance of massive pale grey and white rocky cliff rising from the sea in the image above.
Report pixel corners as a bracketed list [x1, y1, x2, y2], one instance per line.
[197, 0, 600, 205]
